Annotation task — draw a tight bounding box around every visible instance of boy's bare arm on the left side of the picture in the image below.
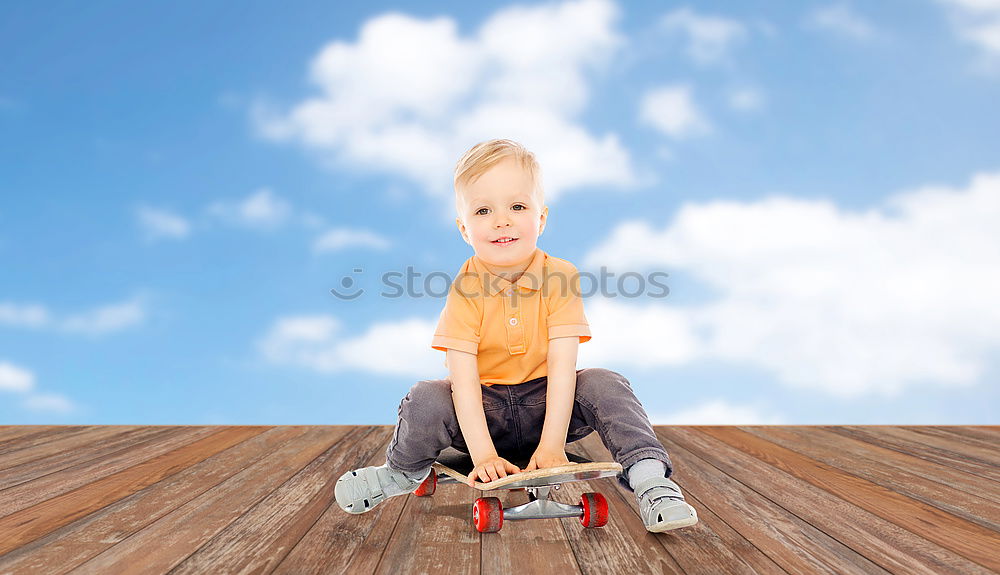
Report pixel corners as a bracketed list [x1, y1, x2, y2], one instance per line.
[448, 349, 520, 482]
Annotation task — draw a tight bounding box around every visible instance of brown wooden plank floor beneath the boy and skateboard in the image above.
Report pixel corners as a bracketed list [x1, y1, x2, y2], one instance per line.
[0, 426, 1000, 575]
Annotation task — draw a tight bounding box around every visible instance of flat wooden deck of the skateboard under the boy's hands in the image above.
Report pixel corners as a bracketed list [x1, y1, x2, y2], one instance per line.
[433, 448, 622, 491]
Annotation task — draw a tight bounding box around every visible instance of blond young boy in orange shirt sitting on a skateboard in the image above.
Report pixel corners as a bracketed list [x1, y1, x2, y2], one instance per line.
[335, 140, 698, 532]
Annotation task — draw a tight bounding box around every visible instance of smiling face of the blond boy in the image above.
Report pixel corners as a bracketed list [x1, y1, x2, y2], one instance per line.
[455, 157, 549, 271]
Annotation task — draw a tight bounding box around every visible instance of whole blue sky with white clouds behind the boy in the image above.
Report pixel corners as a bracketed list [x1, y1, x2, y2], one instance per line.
[0, 0, 1000, 424]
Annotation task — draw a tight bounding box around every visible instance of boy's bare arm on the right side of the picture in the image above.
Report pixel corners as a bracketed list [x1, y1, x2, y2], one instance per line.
[524, 335, 580, 471]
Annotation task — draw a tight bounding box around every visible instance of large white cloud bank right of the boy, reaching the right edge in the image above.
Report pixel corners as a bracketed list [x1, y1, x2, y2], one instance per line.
[581, 169, 1000, 397]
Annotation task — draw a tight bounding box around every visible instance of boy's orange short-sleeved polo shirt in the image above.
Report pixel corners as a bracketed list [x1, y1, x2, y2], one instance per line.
[431, 248, 590, 386]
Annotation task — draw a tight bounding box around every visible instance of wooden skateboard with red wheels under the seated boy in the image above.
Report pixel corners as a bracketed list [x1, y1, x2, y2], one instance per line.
[413, 448, 622, 533]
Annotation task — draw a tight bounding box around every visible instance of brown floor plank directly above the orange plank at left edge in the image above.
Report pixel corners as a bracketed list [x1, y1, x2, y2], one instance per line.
[0, 427, 218, 517]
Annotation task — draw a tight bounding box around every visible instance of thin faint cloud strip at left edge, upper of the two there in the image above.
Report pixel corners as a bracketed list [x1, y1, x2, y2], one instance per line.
[0, 297, 147, 335]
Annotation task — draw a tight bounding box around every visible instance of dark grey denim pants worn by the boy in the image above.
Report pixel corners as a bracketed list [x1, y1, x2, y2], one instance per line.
[385, 368, 673, 491]
